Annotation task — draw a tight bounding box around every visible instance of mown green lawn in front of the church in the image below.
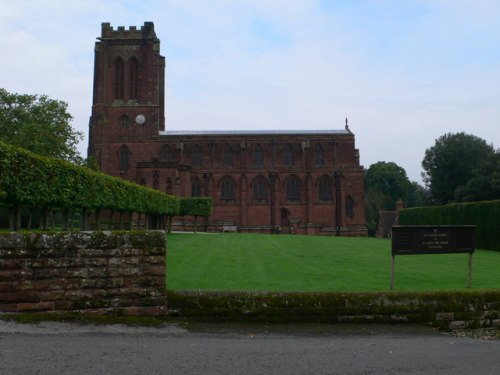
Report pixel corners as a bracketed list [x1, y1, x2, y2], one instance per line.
[167, 233, 500, 291]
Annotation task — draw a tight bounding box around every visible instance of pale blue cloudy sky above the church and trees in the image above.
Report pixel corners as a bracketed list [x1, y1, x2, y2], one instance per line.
[0, 0, 500, 183]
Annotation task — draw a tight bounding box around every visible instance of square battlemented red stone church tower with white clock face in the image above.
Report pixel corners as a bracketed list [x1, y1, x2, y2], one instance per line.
[88, 22, 165, 179]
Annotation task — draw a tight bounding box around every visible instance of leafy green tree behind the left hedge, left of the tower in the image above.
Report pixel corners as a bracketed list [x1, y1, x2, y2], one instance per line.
[0, 88, 83, 163]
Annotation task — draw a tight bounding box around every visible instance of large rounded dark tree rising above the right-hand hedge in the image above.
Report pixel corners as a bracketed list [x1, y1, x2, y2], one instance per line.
[422, 132, 495, 204]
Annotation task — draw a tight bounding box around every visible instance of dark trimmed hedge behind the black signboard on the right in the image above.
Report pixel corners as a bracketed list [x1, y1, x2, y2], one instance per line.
[399, 200, 500, 250]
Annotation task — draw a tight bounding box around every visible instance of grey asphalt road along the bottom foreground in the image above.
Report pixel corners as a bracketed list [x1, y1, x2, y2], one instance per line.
[0, 320, 500, 375]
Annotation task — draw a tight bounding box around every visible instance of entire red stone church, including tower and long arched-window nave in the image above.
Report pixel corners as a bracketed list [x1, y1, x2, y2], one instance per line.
[88, 22, 366, 236]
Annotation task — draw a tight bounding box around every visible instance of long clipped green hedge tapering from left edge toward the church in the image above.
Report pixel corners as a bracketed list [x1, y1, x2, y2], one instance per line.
[0, 142, 179, 216]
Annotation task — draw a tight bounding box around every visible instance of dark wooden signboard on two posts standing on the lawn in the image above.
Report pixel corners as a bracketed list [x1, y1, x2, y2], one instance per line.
[390, 225, 476, 290]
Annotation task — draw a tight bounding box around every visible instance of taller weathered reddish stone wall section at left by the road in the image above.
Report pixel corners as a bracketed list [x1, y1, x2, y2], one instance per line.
[0, 231, 167, 315]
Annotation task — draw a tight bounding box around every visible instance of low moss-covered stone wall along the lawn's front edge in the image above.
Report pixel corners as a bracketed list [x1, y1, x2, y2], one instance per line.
[168, 290, 500, 330]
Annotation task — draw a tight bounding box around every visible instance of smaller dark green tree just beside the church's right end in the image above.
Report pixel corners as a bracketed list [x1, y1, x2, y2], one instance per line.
[365, 161, 412, 233]
